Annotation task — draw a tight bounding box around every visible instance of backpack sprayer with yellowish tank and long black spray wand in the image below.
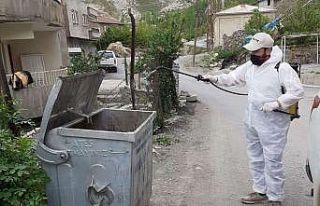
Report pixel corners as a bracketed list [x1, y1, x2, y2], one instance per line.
[155, 66, 300, 120]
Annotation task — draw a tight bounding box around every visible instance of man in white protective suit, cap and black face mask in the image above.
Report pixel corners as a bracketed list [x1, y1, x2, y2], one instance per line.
[203, 33, 304, 206]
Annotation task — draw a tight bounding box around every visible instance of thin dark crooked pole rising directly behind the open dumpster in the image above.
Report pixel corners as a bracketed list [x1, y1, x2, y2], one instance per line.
[128, 8, 136, 110]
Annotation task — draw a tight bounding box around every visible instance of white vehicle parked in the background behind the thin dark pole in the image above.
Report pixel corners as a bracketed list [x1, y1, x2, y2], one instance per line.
[98, 50, 118, 72]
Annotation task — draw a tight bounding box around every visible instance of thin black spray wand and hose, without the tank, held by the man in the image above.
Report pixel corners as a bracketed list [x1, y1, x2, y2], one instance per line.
[155, 66, 292, 116]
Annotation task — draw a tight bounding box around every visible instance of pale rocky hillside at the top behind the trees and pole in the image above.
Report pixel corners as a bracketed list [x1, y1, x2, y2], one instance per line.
[87, 0, 194, 19]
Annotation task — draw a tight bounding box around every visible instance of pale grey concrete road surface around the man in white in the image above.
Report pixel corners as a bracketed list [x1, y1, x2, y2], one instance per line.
[176, 69, 318, 206]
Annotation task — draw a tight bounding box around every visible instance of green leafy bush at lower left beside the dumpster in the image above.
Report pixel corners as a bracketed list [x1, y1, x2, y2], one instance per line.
[0, 97, 48, 206]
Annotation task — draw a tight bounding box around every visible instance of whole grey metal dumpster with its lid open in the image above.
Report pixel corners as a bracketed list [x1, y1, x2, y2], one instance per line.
[37, 71, 155, 206]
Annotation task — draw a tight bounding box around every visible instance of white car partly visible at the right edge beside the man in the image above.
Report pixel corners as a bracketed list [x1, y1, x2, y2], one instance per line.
[306, 92, 320, 206]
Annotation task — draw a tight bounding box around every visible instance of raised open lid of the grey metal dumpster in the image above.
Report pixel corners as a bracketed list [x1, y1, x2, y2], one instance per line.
[39, 70, 104, 143]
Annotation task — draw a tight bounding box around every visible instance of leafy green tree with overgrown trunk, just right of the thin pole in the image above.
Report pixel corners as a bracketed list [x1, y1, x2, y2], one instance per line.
[137, 13, 183, 127]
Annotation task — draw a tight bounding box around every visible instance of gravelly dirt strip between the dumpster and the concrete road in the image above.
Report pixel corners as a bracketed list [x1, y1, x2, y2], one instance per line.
[150, 103, 210, 206]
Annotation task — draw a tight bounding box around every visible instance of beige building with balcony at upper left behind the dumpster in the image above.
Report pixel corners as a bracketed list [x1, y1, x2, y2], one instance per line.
[0, 0, 68, 117]
